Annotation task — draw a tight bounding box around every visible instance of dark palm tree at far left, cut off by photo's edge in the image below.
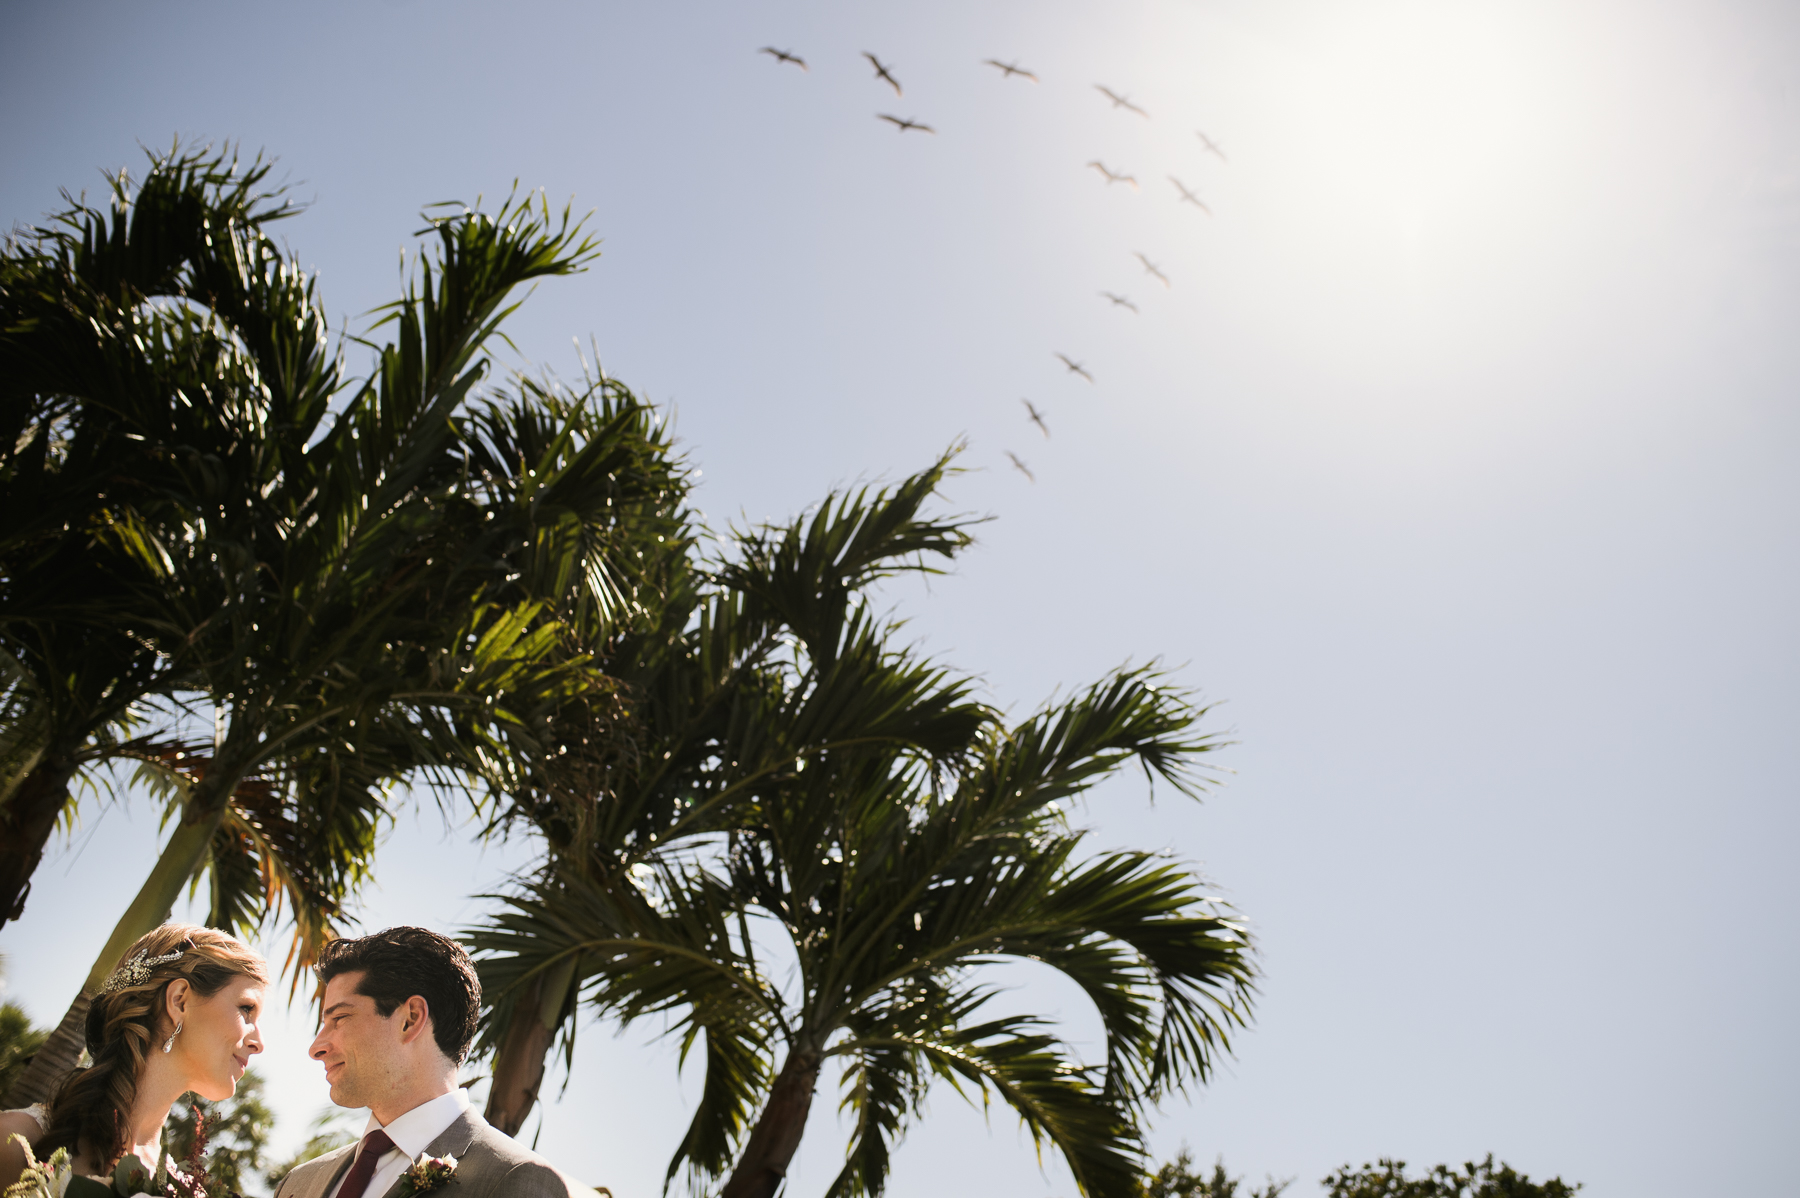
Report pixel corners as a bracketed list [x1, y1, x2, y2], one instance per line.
[0, 142, 322, 921]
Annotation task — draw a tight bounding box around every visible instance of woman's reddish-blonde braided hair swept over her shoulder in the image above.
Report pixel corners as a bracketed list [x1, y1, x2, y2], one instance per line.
[38, 923, 268, 1171]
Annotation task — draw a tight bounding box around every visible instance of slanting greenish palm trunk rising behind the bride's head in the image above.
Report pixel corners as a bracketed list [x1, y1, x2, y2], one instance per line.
[5, 770, 243, 1108]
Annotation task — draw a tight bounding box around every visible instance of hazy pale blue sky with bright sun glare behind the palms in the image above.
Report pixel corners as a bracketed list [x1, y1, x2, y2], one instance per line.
[0, 0, 1800, 1198]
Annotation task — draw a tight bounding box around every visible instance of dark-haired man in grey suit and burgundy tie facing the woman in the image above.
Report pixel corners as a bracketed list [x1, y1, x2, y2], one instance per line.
[275, 928, 594, 1198]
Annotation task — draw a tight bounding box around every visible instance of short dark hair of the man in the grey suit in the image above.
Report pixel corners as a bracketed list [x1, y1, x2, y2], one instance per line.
[313, 928, 481, 1065]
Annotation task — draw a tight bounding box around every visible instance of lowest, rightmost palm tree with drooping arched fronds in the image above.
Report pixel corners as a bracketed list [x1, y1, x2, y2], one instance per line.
[472, 543, 1253, 1198]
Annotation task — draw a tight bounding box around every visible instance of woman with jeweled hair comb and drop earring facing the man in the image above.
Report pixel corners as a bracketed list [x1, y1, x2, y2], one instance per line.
[0, 923, 268, 1198]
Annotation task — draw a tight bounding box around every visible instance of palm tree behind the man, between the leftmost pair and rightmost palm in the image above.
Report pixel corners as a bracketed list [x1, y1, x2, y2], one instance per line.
[472, 455, 988, 1133]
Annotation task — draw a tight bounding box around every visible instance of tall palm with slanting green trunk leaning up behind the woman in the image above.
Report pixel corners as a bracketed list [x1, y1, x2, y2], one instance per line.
[9, 149, 633, 1101]
